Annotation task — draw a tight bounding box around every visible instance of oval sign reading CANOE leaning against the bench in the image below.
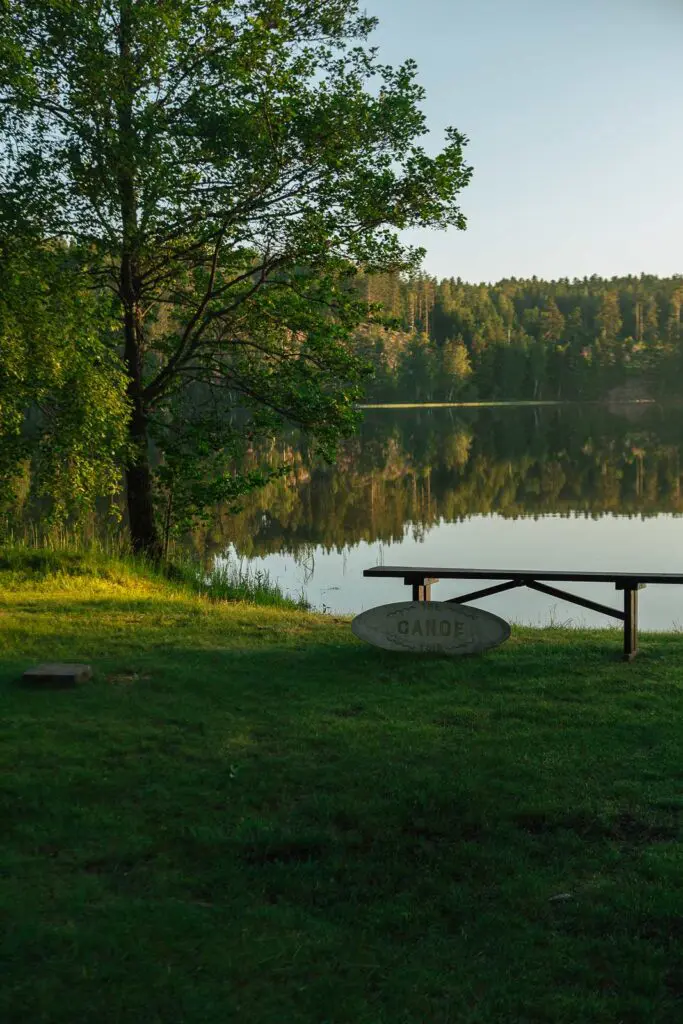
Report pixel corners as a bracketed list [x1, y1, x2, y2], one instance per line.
[351, 601, 510, 654]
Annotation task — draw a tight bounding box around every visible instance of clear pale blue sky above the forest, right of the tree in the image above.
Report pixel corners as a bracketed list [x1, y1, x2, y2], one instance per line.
[361, 0, 683, 282]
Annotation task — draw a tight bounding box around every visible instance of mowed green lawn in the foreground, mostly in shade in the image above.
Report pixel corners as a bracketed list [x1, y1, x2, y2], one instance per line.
[0, 567, 683, 1024]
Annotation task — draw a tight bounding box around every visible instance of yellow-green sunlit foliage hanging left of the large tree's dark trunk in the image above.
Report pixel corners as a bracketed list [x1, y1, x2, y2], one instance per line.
[0, 244, 128, 519]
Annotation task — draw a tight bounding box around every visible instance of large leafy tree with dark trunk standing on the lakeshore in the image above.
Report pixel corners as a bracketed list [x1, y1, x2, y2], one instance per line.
[0, 0, 470, 556]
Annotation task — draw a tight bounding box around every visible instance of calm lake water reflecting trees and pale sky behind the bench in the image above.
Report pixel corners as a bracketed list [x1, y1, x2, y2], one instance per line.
[216, 406, 683, 630]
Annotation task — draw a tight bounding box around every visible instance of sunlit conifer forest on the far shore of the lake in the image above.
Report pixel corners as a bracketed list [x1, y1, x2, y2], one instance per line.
[356, 274, 683, 402]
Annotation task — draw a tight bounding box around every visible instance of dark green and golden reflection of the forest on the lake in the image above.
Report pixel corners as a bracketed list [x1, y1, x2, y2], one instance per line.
[207, 407, 683, 570]
